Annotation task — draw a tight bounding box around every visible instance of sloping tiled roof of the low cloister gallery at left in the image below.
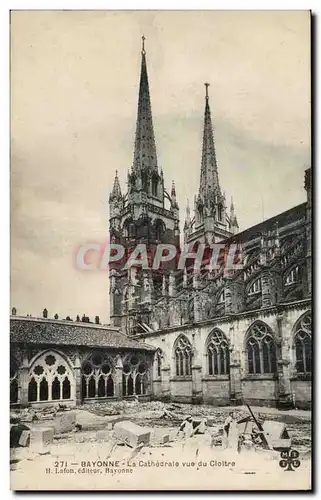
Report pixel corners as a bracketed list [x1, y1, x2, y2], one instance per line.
[10, 316, 155, 351]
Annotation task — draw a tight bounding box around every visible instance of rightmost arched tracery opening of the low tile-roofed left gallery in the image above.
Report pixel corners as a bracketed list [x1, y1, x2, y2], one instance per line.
[123, 354, 149, 397]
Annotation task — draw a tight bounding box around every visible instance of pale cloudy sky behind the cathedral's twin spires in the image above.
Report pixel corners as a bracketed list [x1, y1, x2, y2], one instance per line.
[11, 11, 310, 322]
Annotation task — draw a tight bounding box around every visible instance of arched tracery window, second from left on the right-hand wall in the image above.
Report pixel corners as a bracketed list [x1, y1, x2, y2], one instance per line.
[207, 330, 230, 375]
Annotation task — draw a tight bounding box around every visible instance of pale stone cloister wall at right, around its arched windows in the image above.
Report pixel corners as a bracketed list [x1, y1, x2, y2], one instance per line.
[144, 300, 311, 408]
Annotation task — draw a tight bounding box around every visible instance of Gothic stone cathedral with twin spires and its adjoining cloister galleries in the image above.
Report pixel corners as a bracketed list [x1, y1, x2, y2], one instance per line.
[10, 39, 312, 409]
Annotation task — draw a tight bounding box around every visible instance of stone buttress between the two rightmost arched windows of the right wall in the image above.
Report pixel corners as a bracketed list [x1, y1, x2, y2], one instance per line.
[276, 314, 293, 410]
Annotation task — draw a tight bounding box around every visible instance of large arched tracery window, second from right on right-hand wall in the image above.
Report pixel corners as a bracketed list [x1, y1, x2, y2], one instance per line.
[246, 322, 276, 374]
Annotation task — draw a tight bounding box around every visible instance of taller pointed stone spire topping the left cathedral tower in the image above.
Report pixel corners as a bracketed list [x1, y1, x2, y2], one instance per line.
[133, 36, 157, 171]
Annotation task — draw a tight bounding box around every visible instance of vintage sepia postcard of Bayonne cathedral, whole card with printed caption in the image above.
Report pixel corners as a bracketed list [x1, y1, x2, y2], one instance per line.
[10, 10, 312, 491]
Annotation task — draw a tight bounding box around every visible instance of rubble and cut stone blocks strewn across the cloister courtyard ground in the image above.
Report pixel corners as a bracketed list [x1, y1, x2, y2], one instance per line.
[10, 400, 311, 474]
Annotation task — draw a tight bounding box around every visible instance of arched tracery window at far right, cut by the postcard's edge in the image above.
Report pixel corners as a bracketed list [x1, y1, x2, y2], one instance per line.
[294, 313, 312, 373]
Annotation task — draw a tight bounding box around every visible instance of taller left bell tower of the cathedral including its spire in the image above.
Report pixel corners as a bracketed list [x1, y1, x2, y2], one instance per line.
[109, 36, 180, 335]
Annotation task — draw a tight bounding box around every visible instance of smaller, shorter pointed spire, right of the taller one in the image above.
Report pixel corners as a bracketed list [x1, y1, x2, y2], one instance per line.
[199, 83, 221, 197]
